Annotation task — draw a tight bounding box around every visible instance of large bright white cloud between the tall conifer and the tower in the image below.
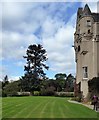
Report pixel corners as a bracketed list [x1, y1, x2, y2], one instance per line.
[43, 15, 75, 73]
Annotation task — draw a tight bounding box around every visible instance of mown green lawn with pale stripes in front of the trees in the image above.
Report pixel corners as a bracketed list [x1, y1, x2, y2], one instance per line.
[2, 97, 97, 118]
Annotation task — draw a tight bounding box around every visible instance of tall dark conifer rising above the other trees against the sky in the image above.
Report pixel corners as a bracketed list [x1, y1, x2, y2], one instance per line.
[23, 44, 49, 90]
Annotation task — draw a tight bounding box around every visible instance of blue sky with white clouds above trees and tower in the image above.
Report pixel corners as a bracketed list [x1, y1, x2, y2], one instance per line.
[0, 0, 97, 80]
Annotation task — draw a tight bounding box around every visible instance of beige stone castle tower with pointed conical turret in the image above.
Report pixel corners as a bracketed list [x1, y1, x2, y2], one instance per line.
[74, 4, 99, 97]
